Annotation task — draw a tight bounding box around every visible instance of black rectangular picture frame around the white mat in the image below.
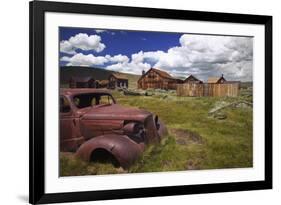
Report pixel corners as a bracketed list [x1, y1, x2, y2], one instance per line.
[29, 1, 272, 204]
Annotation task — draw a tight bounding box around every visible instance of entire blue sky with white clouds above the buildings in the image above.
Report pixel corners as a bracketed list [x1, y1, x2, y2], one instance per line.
[59, 27, 253, 81]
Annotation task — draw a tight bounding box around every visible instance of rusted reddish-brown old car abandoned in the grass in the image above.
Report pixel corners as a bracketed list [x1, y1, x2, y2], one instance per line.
[60, 89, 167, 168]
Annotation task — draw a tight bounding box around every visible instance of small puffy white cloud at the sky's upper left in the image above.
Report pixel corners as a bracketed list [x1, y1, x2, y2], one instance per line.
[60, 33, 106, 54]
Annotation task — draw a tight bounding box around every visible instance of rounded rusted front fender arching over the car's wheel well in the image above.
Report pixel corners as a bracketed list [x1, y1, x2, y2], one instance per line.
[76, 134, 144, 168]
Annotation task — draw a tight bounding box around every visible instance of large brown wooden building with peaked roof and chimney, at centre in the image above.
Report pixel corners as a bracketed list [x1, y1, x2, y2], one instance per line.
[138, 68, 182, 90]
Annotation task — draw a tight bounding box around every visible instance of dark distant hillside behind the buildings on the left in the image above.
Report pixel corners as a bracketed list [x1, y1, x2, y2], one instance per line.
[60, 66, 140, 88]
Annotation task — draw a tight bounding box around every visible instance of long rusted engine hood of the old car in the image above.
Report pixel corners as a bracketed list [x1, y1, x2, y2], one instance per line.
[78, 104, 152, 121]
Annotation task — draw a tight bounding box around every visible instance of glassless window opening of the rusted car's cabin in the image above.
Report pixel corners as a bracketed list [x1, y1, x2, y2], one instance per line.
[73, 93, 115, 109]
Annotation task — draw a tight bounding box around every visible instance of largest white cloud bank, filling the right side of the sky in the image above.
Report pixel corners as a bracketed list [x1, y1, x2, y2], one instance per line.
[118, 34, 253, 81]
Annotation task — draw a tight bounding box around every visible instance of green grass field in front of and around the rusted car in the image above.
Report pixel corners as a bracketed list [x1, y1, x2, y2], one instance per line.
[60, 91, 253, 176]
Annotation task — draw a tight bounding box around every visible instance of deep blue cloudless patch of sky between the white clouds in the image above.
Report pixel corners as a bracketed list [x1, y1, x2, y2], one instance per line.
[60, 28, 181, 56]
